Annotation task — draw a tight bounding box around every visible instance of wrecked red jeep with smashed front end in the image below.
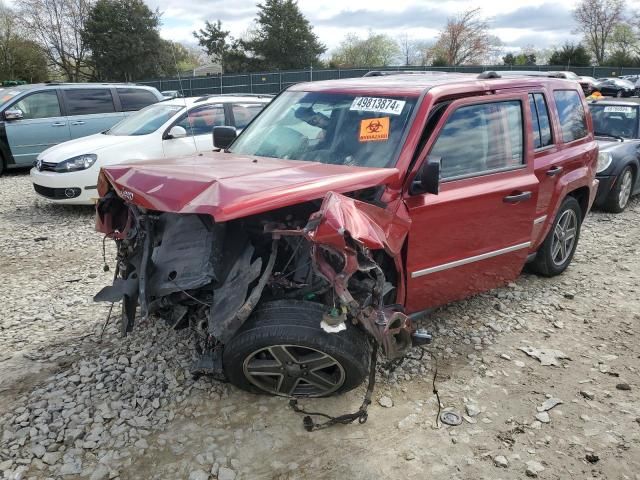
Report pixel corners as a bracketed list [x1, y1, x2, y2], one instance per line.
[96, 73, 597, 397]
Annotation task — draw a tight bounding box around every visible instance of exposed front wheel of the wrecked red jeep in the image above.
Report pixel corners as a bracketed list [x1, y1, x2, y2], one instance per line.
[222, 300, 370, 397]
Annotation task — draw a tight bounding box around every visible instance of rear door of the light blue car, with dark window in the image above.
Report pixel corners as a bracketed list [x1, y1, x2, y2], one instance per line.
[62, 87, 124, 138]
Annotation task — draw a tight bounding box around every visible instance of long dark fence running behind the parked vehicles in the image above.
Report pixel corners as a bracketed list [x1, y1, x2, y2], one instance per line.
[138, 65, 640, 97]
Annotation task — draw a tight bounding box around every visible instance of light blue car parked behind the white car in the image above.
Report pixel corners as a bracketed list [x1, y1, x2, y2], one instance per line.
[0, 83, 162, 173]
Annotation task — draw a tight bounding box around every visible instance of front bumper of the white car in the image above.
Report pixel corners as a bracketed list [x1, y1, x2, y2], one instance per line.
[31, 168, 98, 205]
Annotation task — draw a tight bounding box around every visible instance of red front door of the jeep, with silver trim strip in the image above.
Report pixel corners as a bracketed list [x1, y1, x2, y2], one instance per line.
[405, 93, 538, 312]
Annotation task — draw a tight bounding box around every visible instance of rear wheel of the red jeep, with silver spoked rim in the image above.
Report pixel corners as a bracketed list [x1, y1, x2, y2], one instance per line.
[531, 196, 582, 277]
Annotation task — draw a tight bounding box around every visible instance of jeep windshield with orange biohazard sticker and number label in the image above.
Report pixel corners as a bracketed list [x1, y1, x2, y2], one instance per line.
[229, 92, 416, 167]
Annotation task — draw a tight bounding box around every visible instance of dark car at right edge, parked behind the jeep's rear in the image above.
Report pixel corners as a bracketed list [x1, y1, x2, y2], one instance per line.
[589, 100, 640, 213]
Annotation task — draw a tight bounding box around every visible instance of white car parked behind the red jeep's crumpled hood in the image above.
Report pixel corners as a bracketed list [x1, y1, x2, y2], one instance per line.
[31, 95, 272, 205]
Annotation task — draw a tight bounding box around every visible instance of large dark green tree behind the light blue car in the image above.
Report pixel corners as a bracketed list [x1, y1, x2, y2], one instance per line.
[82, 0, 166, 81]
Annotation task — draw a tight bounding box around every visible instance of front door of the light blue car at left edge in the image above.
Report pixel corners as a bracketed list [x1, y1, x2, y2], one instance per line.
[3, 87, 71, 166]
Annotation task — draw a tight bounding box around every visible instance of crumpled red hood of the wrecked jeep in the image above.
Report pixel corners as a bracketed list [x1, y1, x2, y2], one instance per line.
[99, 152, 399, 222]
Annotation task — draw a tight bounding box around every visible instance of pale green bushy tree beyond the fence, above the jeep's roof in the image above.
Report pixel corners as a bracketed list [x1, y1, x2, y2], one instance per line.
[331, 31, 401, 68]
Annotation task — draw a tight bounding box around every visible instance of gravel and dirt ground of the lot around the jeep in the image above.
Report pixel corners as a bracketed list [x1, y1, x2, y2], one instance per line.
[0, 173, 640, 480]
